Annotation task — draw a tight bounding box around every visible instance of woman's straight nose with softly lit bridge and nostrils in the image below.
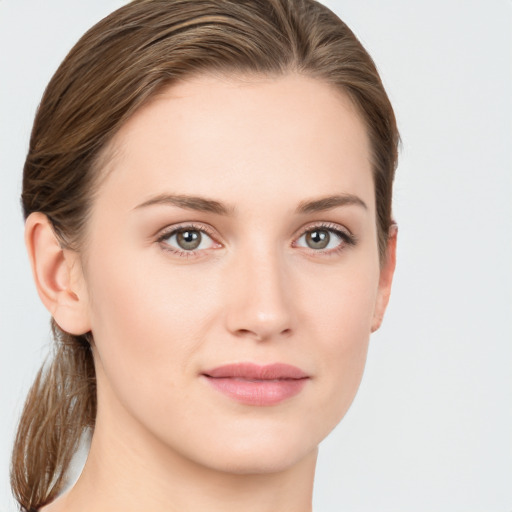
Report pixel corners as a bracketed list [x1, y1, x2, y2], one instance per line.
[225, 244, 295, 341]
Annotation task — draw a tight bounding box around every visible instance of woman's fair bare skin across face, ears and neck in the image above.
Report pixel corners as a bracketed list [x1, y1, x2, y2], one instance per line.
[26, 74, 396, 512]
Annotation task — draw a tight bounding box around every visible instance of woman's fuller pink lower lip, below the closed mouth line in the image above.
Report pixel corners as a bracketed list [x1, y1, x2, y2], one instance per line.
[204, 375, 308, 405]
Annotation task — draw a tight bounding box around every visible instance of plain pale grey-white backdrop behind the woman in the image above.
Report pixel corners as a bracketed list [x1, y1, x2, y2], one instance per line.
[0, 0, 512, 512]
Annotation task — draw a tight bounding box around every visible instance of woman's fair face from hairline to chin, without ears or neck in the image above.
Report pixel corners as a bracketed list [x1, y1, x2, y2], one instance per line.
[76, 75, 394, 473]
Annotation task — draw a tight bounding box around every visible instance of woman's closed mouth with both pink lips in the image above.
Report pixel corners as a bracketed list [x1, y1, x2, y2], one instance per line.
[201, 363, 310, 406]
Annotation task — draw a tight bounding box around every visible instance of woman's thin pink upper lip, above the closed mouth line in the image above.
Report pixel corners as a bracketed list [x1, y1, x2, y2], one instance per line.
[203, 363, 309, 380]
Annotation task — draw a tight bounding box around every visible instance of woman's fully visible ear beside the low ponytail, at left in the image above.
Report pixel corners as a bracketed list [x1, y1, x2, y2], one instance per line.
[25, 212, 91, 335]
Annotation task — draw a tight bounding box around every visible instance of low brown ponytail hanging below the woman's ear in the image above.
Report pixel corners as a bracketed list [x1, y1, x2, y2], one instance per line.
[11, 319, 96, 510]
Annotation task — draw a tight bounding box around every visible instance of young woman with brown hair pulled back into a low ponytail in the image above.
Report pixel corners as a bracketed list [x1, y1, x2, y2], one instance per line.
[12, 0, 398, 512]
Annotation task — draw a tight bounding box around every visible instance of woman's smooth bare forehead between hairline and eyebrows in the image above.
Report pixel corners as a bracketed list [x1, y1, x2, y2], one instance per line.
[95, 74, 373, 214]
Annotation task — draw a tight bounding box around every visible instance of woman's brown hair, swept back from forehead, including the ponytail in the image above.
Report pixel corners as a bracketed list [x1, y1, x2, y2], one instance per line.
[11, 0, 399, 510]
